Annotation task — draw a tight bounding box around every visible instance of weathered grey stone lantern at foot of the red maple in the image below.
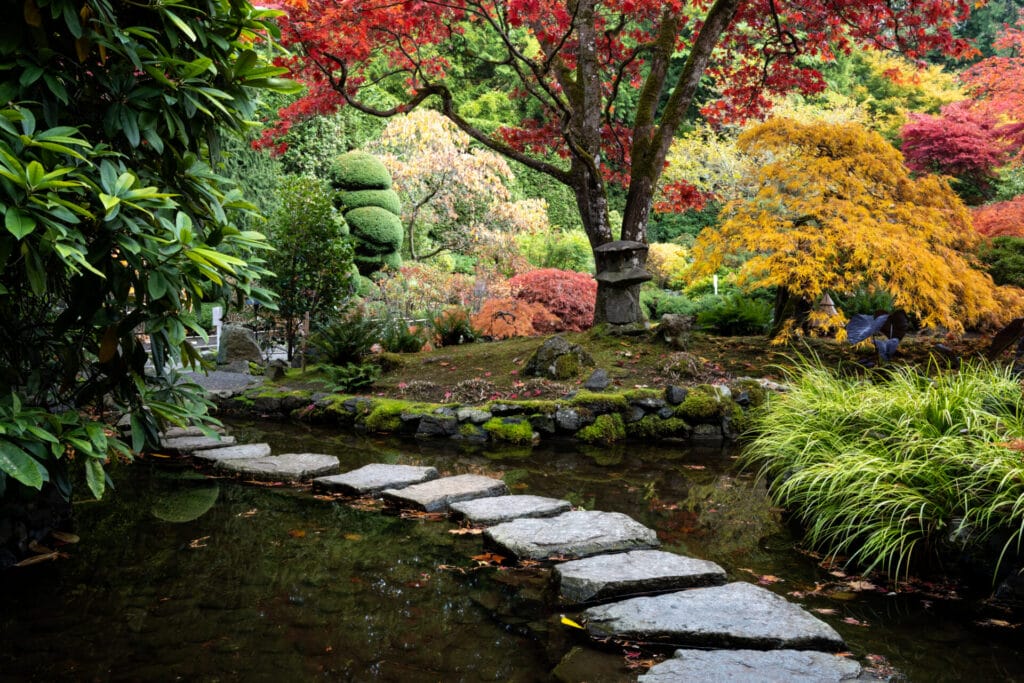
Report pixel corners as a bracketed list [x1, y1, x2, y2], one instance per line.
[594, 240, 651, 325]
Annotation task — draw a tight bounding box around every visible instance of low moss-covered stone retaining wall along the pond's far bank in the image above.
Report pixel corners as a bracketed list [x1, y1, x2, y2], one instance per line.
[211, 379, 778, 444]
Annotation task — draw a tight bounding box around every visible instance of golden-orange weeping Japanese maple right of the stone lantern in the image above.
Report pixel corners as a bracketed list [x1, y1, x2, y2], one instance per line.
[693, 119, 1013, 333]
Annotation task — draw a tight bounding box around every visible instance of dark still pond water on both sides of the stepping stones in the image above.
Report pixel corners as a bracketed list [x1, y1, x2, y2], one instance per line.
[0, 422, 1024, 682]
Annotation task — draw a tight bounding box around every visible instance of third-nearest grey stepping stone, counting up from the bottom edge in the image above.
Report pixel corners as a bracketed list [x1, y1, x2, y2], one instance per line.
[554, 550, 725, 604]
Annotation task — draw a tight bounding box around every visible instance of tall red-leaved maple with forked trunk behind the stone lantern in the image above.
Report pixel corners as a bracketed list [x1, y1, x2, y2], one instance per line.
[270, 0, 971, 325]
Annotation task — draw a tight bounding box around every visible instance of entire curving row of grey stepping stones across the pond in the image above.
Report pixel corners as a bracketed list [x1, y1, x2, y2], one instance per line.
[151, 432, 870, 683]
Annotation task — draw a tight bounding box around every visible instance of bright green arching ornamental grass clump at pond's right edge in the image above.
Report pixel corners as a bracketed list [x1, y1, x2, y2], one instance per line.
[743, 362, 1024, 580]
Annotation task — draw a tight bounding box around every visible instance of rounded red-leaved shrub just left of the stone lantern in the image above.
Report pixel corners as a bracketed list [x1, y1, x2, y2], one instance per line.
[509, 268, 597, 334]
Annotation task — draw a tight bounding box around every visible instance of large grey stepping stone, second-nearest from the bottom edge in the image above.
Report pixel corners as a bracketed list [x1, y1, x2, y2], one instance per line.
[583, 582, 845, 651]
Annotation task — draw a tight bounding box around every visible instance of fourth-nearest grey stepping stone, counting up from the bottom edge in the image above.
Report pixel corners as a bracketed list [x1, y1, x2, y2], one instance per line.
[483, 510, 659, 560]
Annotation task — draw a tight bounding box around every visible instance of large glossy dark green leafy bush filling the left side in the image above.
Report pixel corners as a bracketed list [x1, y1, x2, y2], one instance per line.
[0, 0, 295, 497]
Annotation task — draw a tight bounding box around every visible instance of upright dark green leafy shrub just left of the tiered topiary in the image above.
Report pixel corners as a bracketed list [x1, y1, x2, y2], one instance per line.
[267, 176, 353, 359]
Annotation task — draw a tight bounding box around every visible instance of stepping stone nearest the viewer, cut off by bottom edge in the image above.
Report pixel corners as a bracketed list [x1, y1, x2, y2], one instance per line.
[637, 650, 861, 683]
